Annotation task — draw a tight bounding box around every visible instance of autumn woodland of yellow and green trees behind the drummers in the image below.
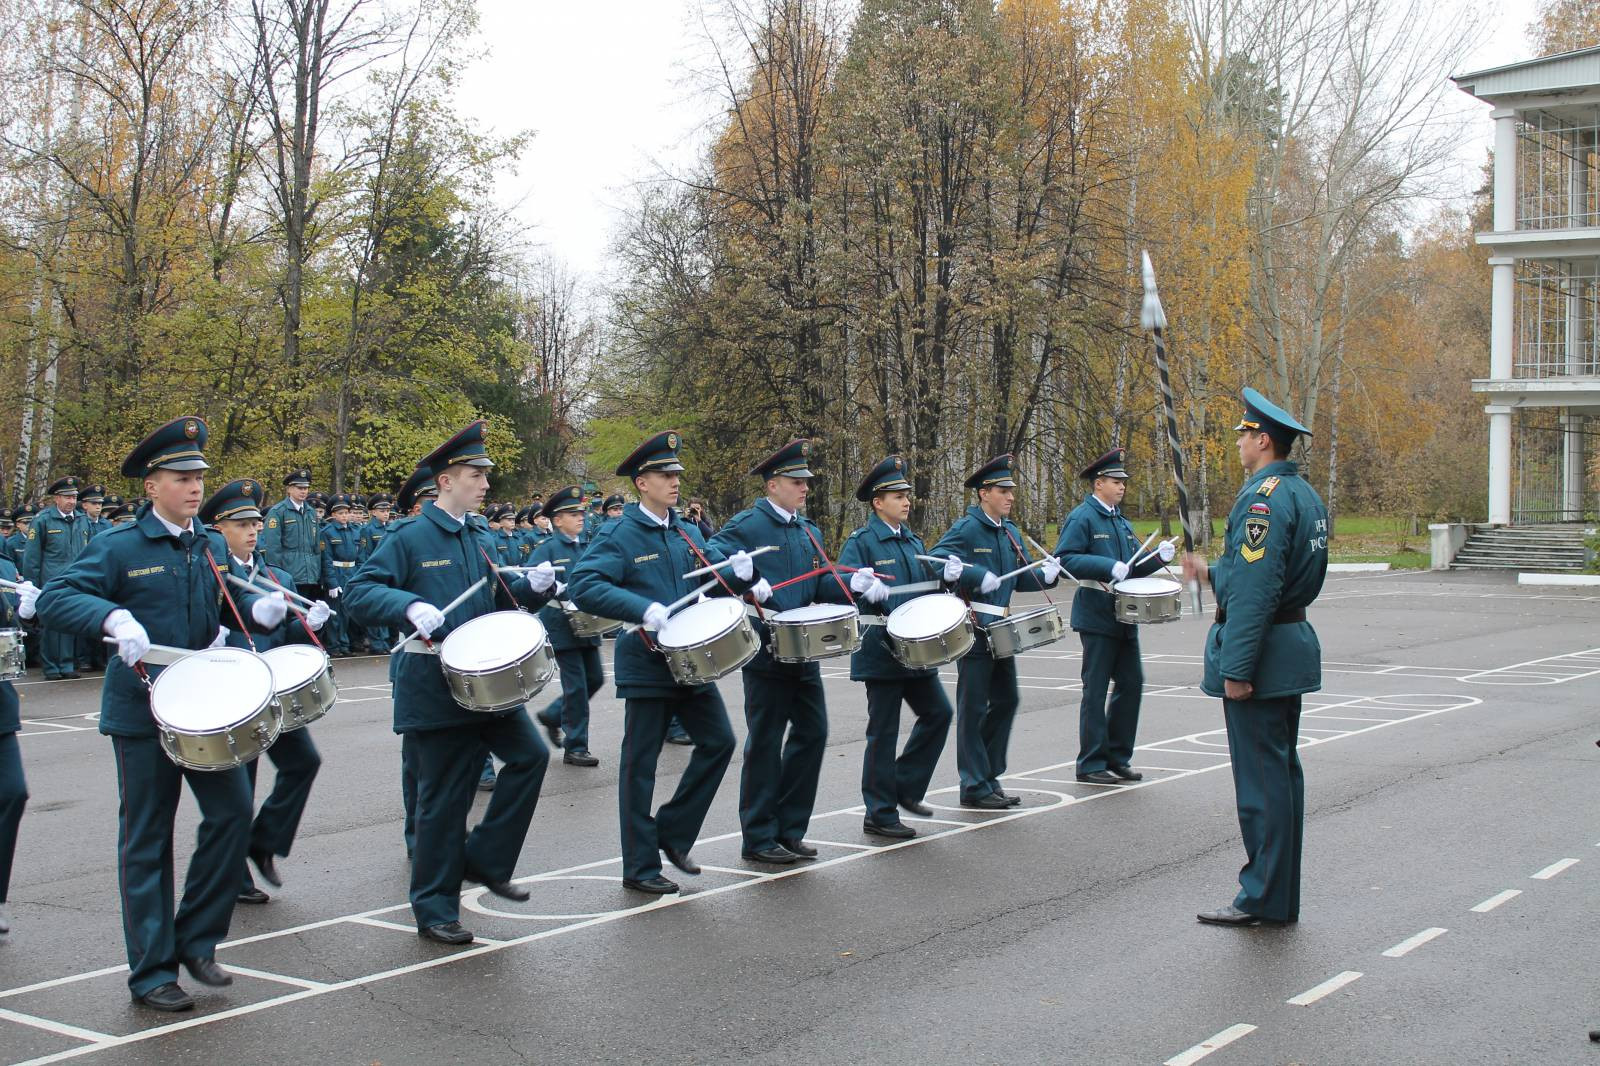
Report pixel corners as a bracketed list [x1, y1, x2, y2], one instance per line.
[0, 0, 1594, 535]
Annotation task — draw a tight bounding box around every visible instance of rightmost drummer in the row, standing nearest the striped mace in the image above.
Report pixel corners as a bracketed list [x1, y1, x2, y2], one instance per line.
[1056, 448, 1174, 784]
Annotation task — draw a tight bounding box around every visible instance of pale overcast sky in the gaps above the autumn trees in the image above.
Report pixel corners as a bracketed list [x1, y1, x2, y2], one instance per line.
[459, 0, 1536, 277]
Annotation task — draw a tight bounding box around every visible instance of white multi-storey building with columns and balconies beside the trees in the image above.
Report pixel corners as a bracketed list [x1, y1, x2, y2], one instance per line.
[1453, 48, 1600, 525]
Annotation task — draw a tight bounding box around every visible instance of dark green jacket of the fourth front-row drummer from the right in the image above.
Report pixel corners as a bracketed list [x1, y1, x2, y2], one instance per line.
[710, 499, 850, 677]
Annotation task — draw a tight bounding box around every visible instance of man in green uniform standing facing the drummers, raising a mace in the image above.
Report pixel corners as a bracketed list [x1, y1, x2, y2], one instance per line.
[1184, 389, 1328, 925]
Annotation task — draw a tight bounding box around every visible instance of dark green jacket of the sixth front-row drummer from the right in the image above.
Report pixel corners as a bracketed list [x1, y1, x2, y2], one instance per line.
[339, 501, 549, 733]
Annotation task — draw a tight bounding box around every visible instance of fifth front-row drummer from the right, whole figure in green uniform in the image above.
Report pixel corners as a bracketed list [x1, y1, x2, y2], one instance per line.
[570, 432, 758, 895]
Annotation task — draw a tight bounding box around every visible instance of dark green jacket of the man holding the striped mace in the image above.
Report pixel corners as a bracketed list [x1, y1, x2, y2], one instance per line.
[1200, 459, 1328, 699]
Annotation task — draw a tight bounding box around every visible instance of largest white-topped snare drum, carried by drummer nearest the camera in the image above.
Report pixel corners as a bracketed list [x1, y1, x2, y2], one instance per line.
[150, 648, 283, 770]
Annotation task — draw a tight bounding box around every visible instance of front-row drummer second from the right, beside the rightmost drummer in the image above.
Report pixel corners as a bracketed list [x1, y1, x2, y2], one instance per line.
[928, 455, 1061, 810]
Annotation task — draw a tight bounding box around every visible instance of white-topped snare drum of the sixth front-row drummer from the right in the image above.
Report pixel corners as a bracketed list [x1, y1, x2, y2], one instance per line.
[438, 611, 555, 711]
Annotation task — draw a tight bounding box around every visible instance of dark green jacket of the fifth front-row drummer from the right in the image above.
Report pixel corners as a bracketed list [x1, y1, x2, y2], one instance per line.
[568, 504, 762, 699]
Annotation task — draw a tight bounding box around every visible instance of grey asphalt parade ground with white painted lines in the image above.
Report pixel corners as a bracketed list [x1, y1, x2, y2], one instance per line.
[0, 573, 1600, 1066]
